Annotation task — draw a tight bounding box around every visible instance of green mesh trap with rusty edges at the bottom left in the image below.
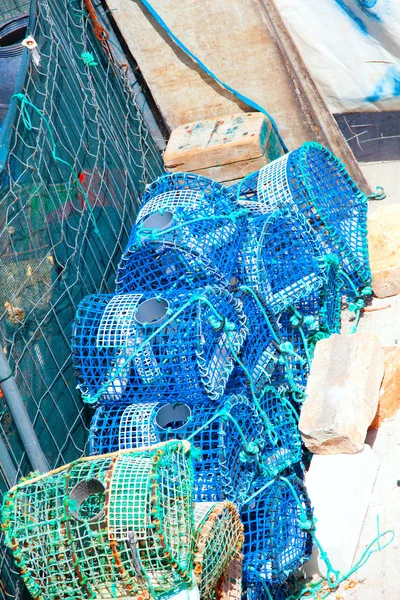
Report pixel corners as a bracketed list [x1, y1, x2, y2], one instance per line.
[3, 441, 193, 600]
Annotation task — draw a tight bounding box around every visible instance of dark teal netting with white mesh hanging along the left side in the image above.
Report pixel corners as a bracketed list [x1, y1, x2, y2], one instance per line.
[0, 0, 162, 597]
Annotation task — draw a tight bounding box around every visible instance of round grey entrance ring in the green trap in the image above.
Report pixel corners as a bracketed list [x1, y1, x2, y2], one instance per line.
[69, 478, 106, 523]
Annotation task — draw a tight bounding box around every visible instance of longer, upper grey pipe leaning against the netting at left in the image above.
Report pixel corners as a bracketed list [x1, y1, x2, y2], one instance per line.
[0, 351, 50, 473]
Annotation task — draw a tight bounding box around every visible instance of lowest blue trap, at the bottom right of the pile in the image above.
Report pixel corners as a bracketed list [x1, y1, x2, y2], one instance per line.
[240, 475, 312, 585]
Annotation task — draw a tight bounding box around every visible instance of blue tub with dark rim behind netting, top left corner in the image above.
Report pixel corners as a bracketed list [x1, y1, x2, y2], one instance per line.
[0, 15, 28, 128]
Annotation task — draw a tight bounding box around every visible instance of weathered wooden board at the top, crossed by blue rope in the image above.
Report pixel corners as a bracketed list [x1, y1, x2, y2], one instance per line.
[107, 0, 320, 149]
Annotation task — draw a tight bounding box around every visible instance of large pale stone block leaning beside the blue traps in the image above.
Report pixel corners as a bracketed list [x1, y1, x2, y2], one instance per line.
[299, 332, 384, 454]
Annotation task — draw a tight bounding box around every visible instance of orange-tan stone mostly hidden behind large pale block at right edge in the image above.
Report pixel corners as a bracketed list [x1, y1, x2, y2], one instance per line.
[369, 346, 400, 429]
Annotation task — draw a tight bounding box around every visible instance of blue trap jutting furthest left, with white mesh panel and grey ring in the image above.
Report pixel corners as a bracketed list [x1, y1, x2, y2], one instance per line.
[72, 288, 247, 404]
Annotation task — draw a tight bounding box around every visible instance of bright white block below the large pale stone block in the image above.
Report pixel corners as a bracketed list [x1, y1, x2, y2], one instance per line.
[302, 446, 379, 577]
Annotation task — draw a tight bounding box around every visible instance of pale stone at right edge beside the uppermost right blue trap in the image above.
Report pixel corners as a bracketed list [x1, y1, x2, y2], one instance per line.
[368, 204, 400, 298]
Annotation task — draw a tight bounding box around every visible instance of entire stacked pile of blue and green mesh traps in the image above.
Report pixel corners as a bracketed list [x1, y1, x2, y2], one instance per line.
[3, 143, 370, 600]
